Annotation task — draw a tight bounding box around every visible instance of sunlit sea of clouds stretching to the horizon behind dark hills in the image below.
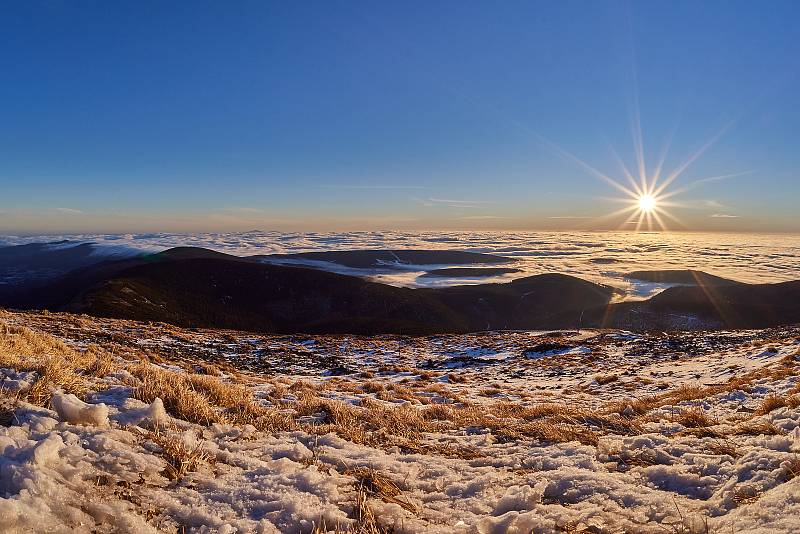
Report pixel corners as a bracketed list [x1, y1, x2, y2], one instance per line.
[0, 231, 800, 297]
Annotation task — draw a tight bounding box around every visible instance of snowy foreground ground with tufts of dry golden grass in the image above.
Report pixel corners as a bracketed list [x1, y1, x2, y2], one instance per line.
[0, 313, 800, 533]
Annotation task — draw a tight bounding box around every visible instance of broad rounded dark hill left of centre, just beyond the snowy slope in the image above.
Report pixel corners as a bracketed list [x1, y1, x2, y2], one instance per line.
[71, 259, 465, 333]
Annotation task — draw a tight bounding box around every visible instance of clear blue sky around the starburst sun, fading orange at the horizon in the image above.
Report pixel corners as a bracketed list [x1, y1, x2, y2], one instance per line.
[0, 1, 800, 233]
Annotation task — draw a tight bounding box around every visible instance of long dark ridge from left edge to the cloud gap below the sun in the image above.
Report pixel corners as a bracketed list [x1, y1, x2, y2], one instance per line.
[5, 249, 614, 333]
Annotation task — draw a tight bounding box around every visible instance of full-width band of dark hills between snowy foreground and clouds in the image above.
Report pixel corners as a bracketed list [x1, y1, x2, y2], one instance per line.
[0, 247, 800, 334]
